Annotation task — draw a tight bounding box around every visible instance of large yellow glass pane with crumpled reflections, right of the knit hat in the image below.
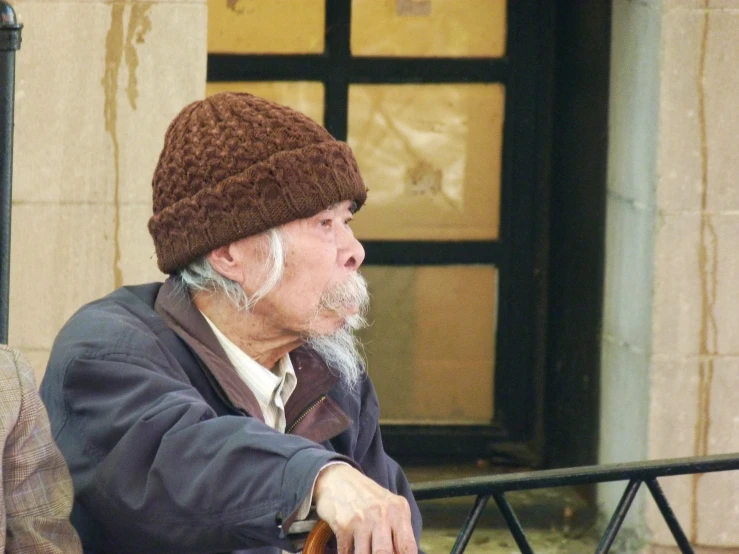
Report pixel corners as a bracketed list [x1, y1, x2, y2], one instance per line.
[348, 84, 504, 240]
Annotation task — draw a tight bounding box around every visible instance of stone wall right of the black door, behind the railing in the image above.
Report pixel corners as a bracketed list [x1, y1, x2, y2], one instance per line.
[600, 0, 739, 553]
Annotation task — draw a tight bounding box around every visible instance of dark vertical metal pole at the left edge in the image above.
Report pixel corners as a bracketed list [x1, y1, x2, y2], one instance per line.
[0, 0, 22, 343]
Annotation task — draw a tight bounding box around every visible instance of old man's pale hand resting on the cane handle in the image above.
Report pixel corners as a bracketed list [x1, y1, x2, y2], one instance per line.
[313, 464, 418, 554]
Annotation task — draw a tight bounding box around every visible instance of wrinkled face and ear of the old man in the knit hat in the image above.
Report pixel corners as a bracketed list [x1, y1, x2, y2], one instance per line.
[235, 201, 364, 337]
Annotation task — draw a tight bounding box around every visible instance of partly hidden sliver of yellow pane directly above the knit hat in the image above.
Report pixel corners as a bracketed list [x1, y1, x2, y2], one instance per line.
[205, 81, 323, 125]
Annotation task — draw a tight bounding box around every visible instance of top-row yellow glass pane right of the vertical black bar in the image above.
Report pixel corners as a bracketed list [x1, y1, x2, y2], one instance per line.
[351, 0, 506, 57]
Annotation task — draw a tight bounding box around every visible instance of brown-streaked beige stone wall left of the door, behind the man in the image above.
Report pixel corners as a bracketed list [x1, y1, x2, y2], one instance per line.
[9, 0, 207, 378]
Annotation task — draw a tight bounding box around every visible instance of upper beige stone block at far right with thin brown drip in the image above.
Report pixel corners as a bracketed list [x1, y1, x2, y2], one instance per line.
[658, 7, 739, 211]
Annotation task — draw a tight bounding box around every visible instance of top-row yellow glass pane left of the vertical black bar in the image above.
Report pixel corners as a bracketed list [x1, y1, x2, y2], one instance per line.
[208, 0, 326, 54]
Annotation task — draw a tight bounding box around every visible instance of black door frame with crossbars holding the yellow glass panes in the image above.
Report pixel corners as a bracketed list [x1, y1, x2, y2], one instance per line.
[208, 0, 554, 465]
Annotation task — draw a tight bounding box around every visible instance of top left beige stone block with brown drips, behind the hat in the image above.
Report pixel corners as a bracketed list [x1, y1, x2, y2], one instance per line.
[14, 2, 207, 202]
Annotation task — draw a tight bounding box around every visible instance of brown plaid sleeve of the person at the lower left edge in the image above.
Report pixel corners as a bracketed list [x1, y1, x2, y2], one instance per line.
[0, 344, 82, 554]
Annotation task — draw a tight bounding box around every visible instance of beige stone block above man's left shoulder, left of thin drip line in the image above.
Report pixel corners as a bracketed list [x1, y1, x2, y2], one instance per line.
[9, 204, 115, 350]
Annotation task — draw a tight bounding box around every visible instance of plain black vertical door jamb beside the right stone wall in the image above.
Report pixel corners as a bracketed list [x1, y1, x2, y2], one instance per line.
[544, 0, 612, 467]
